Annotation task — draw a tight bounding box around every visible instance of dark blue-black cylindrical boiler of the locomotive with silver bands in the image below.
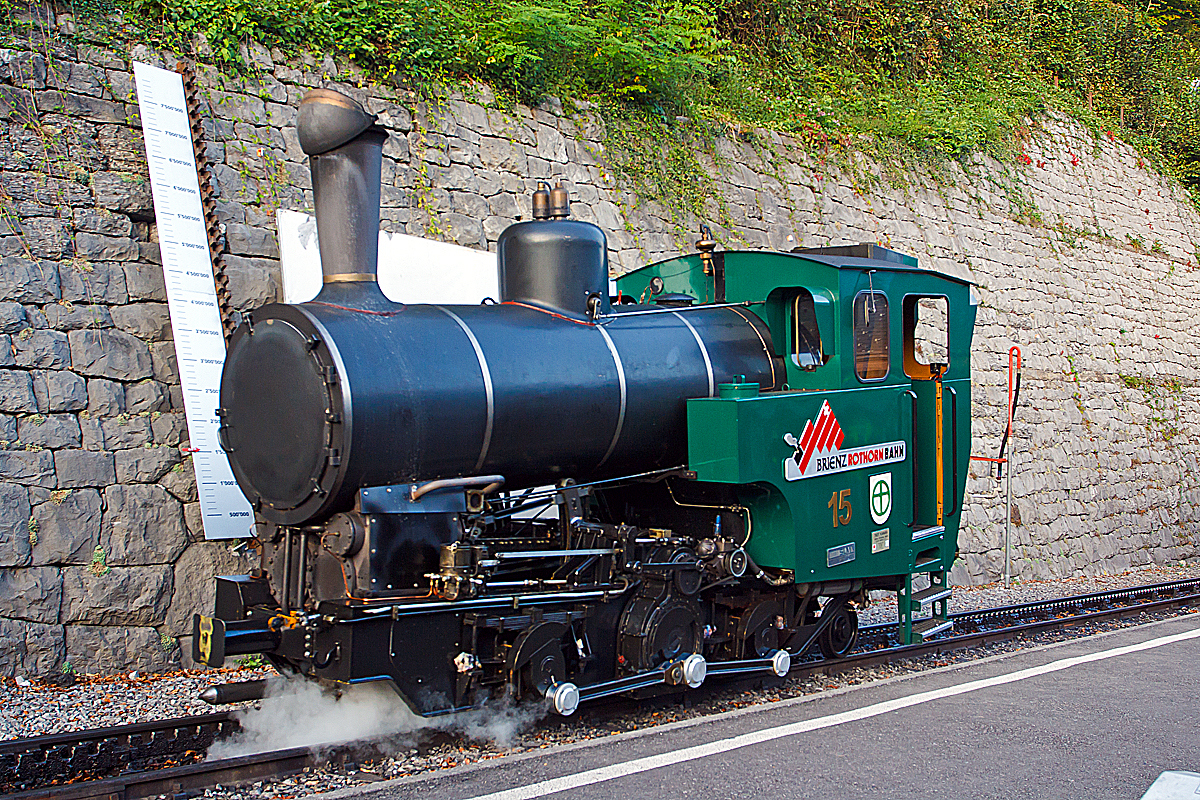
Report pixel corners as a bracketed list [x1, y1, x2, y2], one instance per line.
[218, 299, 784, 524]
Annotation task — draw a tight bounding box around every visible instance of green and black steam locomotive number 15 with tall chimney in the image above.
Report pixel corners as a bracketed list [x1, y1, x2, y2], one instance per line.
[193, 90, 977, 715]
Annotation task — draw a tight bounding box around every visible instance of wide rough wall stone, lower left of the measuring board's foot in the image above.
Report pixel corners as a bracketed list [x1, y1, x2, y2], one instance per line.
[63, 565, 174, 625]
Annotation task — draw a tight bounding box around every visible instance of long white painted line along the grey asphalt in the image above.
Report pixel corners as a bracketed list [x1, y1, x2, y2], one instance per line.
[470, 628, 1200, 800]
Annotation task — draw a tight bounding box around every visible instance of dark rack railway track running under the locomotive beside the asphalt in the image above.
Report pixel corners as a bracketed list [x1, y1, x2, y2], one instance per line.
[9, 579, 1200, 800]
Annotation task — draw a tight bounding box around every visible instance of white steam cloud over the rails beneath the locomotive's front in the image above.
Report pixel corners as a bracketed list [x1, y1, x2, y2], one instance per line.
[208, 678, 547, 760]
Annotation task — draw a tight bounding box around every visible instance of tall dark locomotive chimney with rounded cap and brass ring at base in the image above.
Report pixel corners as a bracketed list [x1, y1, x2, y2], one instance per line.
[296, 89, 388, 301]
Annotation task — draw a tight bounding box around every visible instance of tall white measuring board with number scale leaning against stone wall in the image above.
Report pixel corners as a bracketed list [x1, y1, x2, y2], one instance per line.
[133, 62, 254, 539]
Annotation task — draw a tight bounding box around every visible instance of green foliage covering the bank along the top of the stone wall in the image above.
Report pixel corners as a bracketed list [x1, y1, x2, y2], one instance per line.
[46, 0, 1200, 196]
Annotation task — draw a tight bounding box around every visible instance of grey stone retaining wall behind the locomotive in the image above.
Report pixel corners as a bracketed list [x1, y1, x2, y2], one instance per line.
[0, 9, 1200, 675]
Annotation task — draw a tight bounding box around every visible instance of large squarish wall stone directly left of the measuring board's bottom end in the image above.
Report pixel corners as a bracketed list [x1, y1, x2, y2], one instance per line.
[101, 483, 187, 566]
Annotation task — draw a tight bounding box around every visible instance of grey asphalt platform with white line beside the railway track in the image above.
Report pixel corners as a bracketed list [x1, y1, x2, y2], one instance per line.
[325, 614, 1200, 800]
